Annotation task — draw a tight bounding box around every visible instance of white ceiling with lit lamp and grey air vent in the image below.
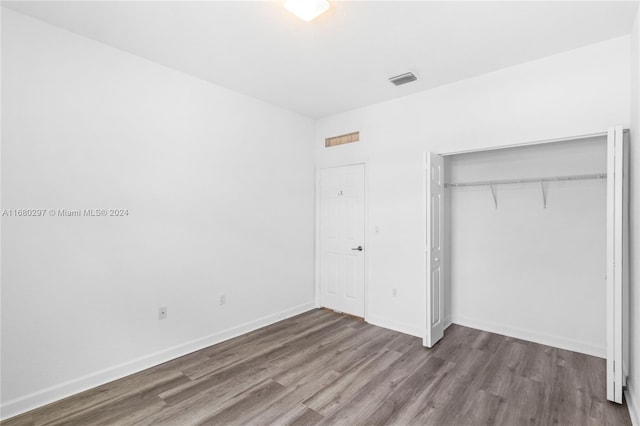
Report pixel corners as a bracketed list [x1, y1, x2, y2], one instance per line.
[3, 1, 638, 118]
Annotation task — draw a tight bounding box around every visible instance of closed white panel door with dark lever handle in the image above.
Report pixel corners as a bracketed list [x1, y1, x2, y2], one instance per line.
[320, 164, 365, 317]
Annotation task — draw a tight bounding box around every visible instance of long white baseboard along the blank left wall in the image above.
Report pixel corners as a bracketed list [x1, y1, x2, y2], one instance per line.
[0, 302, 315, 420]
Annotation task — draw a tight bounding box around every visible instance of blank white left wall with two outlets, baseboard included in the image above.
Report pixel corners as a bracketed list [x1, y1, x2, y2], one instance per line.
[2, 10, 314, 418]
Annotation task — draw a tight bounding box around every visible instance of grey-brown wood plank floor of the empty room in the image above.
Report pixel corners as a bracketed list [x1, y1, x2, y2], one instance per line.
[2, 310, 631, 426]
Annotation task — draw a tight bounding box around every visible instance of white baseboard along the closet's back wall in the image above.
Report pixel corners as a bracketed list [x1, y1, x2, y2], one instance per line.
[451, 316, 607, 358]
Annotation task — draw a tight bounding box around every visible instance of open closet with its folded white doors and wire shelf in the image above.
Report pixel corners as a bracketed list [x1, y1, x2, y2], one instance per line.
[425, 128, 628, 402]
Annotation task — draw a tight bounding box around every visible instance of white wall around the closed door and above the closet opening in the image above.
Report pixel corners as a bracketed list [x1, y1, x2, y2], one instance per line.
[315, 37, 630, 346]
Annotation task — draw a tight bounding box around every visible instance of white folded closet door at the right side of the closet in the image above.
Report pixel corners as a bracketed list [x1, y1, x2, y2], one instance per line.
[607, 127, 629, 404]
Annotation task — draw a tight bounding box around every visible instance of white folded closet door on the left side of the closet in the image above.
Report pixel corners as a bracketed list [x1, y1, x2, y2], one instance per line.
[423, 152, 446, 348]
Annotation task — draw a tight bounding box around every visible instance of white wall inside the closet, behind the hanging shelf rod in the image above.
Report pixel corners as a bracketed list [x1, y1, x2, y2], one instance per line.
[447, 137, 607, 357]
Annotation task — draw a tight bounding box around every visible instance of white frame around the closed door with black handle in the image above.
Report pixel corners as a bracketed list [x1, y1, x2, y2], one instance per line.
[314, 161, 372, 321]
